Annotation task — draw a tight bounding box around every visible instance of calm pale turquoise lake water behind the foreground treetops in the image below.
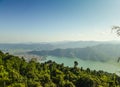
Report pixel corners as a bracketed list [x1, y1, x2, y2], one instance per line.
[43, 56, 120, 75]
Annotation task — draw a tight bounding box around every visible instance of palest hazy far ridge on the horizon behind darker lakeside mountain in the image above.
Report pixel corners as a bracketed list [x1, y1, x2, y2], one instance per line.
[50, 41, 120, 49]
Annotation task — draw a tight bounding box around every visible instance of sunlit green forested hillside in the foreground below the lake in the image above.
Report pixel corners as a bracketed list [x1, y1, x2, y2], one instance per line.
[0, 51, 120, 87]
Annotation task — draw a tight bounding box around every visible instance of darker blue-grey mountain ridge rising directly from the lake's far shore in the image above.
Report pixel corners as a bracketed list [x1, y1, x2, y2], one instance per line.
[29, 44, 120, 61]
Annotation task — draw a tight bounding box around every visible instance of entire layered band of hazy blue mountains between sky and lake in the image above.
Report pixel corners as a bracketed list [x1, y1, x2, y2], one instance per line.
[0, 41, 120, 61]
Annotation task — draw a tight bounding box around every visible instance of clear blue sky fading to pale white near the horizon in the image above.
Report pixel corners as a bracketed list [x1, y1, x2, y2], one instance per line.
[0, 0, 120, 43]
